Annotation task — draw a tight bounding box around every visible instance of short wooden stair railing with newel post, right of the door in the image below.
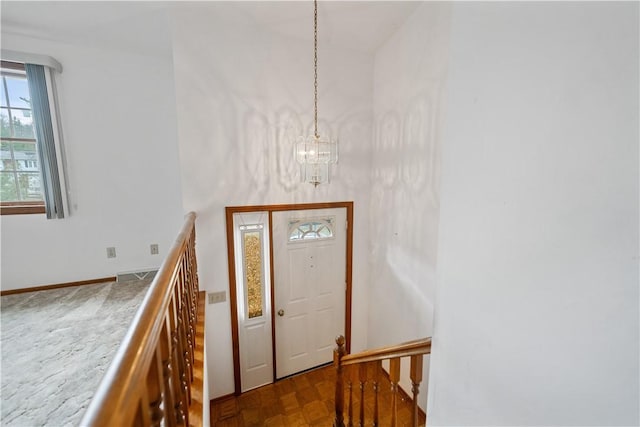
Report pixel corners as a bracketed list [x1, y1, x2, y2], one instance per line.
[333, 335, 431, 427]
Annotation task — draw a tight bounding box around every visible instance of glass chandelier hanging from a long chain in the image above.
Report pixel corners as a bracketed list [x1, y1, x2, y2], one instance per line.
[296, 0, 338, 187]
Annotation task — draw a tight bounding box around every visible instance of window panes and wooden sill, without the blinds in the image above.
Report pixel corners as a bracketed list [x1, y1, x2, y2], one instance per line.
[0, 61, 45, 213]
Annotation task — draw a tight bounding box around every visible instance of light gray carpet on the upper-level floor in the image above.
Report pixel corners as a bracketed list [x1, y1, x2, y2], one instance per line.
[0, 280, 150, 427]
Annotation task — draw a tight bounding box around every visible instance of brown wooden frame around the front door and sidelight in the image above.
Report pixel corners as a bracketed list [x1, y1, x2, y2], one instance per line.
[225, 201, 353, 396]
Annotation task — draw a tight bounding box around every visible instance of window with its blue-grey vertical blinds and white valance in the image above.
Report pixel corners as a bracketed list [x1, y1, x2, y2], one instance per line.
[0, 56, 66, 219]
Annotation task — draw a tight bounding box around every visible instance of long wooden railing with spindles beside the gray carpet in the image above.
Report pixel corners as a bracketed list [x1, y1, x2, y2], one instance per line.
[81, 212, 198, 426]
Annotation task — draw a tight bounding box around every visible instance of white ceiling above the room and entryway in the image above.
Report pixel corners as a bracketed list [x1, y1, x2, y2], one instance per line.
[0, 0, 421, 53]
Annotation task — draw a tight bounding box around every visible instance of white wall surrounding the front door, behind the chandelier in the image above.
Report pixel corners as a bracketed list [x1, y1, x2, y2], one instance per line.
[172, 3, 373, 398]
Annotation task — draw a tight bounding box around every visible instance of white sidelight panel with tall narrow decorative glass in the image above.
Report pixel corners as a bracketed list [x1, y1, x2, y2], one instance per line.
[233, 212, 273, 392]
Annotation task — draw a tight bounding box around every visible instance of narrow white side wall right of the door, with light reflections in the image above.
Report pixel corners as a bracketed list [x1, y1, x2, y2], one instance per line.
[368, 3, 450, 408]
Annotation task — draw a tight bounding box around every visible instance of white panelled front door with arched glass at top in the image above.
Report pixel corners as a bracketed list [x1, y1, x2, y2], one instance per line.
[272, 208, 346, 378]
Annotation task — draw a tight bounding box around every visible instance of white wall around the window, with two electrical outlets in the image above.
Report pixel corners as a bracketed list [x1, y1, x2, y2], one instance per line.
[1, 28, 183, 290]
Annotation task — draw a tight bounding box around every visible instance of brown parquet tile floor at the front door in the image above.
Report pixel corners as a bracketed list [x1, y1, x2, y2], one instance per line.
[211, 365, 425, 427]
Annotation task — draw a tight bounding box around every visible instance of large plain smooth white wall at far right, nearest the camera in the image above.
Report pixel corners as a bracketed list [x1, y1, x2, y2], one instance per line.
[429, 2, 640, 426]
